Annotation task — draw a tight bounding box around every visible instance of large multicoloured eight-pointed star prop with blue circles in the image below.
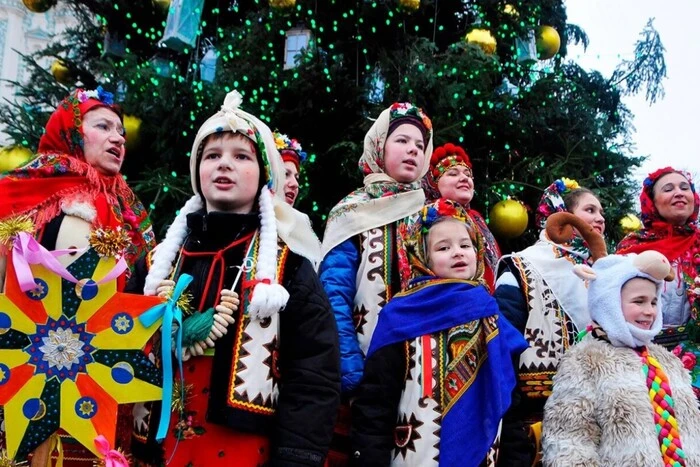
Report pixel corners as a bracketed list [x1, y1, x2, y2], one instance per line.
[0, 249, 162, 459]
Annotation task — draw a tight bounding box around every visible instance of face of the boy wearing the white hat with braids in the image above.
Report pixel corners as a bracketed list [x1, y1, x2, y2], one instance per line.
[199, 133, 260, 214]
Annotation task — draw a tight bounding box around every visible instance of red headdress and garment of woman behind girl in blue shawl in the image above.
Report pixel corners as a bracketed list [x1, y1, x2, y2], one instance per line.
[423, 143, 501, 293]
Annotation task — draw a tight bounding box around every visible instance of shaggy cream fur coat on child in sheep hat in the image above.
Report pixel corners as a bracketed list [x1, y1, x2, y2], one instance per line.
[542, 335, 700, 467]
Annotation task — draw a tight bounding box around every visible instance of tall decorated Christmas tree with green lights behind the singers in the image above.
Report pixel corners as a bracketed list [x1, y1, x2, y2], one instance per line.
[0, 0, 665, 251]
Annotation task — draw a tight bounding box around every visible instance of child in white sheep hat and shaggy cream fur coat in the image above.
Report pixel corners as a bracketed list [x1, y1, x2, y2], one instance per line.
[542, 214, 700, 467]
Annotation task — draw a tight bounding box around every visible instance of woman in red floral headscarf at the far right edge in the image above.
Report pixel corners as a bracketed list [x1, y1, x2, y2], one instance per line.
[617, 167, 700, 394]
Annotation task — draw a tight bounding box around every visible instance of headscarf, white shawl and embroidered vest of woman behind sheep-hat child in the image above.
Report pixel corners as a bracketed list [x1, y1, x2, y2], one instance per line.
[495, 178, 590, 465]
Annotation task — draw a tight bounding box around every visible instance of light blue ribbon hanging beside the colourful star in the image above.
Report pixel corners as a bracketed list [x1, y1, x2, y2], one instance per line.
[139, 274, 192, 441]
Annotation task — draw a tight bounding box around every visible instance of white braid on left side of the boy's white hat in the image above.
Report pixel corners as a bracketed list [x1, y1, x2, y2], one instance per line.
[143, 195, 204, 295]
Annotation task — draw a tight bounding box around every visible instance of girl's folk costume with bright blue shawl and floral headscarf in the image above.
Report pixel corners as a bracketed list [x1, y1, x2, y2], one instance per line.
[352, 199, 526, 466]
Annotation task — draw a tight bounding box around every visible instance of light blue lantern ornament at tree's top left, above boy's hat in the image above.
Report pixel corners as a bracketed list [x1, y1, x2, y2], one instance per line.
[158, 0, 204, 53]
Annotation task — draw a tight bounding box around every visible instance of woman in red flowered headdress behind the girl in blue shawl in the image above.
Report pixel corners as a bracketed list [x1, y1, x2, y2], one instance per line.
[423, 143, 501, 293]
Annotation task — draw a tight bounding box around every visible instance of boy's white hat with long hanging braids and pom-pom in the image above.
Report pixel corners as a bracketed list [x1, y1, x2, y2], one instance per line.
[144, 91, 321, 318]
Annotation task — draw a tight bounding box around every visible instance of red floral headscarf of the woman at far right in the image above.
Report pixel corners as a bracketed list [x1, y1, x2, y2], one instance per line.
[617, 167, 700, 316]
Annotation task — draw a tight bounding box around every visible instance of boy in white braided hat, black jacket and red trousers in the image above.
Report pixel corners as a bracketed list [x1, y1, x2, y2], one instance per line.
[129, 91, 340, 467]
